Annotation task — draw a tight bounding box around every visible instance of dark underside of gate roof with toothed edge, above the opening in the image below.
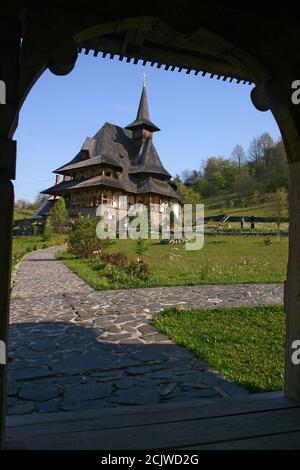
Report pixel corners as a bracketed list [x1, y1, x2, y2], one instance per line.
[74, 17, 269, 82]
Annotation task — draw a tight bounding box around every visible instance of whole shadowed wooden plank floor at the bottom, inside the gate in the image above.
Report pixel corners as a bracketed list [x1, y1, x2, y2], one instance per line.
[6, 398, 300, 450]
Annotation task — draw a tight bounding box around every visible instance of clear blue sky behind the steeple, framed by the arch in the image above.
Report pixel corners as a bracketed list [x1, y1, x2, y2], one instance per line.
[15, 54, 280, 200]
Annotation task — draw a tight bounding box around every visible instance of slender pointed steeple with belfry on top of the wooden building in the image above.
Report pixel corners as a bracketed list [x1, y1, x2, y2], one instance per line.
[126, 79, 160, 140]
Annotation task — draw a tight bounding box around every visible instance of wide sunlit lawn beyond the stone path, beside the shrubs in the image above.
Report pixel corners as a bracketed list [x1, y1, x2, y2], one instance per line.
[61, 236, 288, 290]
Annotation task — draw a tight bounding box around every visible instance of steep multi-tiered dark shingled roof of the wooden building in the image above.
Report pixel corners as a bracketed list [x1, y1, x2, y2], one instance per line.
[43, 86, 178, 198]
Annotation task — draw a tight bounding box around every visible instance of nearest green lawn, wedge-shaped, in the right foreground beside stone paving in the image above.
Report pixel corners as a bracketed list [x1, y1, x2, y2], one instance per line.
[154, 305, 285, 392]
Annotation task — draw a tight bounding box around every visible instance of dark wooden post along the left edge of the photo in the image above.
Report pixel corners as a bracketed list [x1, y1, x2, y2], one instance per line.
[0, 19, 21, 449]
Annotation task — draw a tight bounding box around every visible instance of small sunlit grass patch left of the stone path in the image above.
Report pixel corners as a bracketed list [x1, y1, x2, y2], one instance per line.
[12, 234, 66, 268]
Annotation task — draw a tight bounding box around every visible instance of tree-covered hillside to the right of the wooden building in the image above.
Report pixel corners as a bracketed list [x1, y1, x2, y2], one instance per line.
[175, 133, 288, 215]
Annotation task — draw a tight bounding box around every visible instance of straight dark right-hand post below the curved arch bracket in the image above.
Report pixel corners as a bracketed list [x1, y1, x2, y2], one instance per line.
[284, 161, 300, 400]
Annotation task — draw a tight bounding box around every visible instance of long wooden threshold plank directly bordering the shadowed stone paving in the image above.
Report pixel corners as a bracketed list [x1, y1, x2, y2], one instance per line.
[7, 392, 288, 440]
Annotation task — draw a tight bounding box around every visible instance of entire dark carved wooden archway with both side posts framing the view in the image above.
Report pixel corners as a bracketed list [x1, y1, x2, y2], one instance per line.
[0, 8, 300, 448]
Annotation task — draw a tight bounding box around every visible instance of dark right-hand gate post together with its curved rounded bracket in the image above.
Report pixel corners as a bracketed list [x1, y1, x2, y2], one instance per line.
[251, 83, 300, 401]
